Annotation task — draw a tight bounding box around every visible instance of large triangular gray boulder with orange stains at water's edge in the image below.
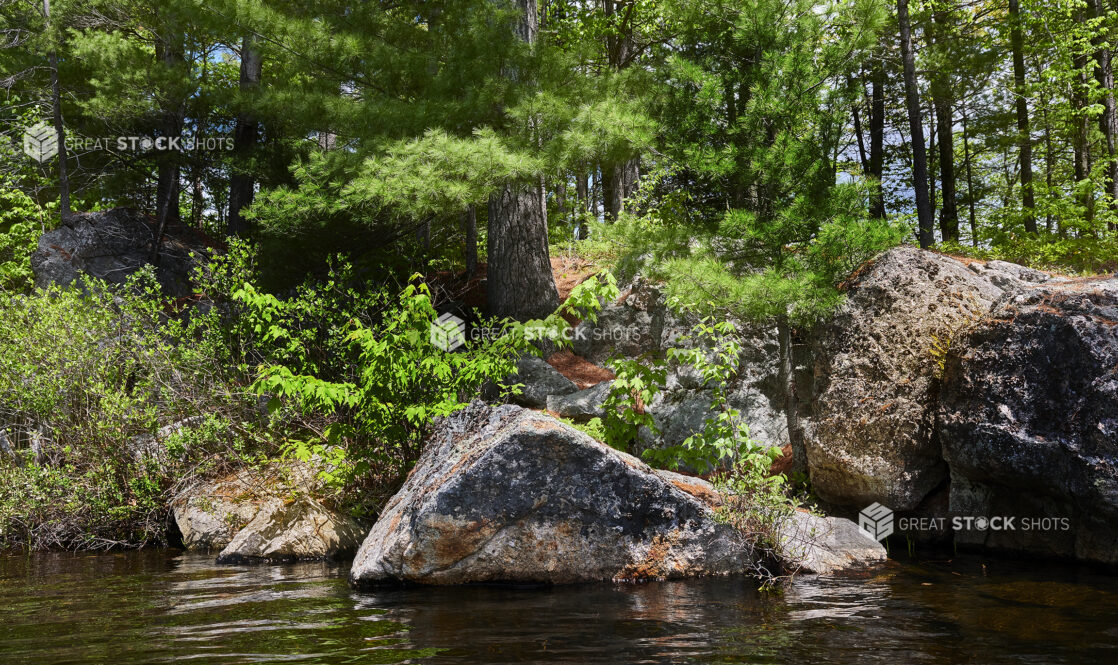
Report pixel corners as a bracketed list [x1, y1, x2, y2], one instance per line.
[350, 403, 747, 586]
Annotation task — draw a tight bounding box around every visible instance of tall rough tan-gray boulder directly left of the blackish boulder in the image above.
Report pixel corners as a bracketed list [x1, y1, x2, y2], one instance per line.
[806, 247, 1046, 511]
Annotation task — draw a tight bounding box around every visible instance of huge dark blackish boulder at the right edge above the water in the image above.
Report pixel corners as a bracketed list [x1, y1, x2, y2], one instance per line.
[938, 278, 1118, 563]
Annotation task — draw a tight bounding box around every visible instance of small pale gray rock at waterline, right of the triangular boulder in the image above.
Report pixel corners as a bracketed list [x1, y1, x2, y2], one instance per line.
[780, 511, 887, 574]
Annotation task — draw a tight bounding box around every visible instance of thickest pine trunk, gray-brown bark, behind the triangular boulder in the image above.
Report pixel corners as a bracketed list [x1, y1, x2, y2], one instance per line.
[486, 0, 559, 320]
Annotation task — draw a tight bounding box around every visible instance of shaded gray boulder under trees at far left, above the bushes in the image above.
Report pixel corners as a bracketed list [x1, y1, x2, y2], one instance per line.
[31, 208, 206, 296]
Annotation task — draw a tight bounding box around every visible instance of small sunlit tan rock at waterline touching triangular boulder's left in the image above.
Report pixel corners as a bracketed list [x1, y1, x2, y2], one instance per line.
[217, 496, 368, 563]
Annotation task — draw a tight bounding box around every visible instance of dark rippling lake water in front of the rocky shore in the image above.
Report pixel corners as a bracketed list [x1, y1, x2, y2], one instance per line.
[0, 551, 1118, 665]
